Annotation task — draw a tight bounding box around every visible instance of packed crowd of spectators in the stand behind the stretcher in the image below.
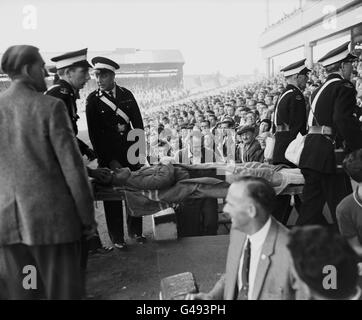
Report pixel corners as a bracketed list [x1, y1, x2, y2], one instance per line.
[144, 55, 362, 163]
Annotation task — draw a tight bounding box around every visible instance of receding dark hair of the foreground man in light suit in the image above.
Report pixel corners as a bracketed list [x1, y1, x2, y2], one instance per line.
[235, 176, 276, 214]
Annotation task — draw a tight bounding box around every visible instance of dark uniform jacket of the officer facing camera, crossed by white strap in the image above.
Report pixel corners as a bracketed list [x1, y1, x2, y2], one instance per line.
[86, 86, 145, 170]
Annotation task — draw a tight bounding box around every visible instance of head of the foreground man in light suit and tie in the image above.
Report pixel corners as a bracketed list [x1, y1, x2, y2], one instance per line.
[224, 176, 276, 235]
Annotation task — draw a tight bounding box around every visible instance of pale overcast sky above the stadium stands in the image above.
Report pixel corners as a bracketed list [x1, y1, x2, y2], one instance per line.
[0, 0, 302, 75]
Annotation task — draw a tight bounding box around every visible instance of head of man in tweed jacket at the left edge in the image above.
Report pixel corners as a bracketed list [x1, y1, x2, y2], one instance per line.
[1, 45, 48, 92]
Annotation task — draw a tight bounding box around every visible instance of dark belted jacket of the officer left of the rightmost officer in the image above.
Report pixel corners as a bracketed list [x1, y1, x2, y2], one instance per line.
[273, 84, 307, 166]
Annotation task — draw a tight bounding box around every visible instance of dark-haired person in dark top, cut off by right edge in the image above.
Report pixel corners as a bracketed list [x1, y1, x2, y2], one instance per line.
[336, 149, 362, 257]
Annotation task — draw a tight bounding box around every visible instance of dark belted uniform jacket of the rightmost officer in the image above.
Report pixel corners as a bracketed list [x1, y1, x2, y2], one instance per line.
[299, 74, 362, 173]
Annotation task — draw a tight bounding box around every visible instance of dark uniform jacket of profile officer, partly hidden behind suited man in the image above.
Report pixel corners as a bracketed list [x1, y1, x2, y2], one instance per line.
[45, 79, 88, 154]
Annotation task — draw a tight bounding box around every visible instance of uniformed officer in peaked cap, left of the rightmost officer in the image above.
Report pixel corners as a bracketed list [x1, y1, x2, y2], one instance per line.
[272, 59, 310, 225]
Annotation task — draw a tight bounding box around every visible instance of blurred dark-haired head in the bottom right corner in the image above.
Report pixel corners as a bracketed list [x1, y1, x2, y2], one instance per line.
[287, 226, 358, 299]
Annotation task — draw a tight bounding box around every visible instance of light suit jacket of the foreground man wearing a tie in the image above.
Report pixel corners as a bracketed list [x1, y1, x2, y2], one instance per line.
[206, 218, 303, 300]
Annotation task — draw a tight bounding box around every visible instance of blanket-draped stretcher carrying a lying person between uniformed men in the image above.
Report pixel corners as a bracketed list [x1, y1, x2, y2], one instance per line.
[93, 163, 304, 217]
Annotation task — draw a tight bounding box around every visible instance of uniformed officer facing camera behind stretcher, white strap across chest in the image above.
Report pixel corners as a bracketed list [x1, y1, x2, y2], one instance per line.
[86, 57, 145, 249]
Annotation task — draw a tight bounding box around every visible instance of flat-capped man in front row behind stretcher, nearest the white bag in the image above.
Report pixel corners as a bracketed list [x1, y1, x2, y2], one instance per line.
[235, 125, 264, 163]
